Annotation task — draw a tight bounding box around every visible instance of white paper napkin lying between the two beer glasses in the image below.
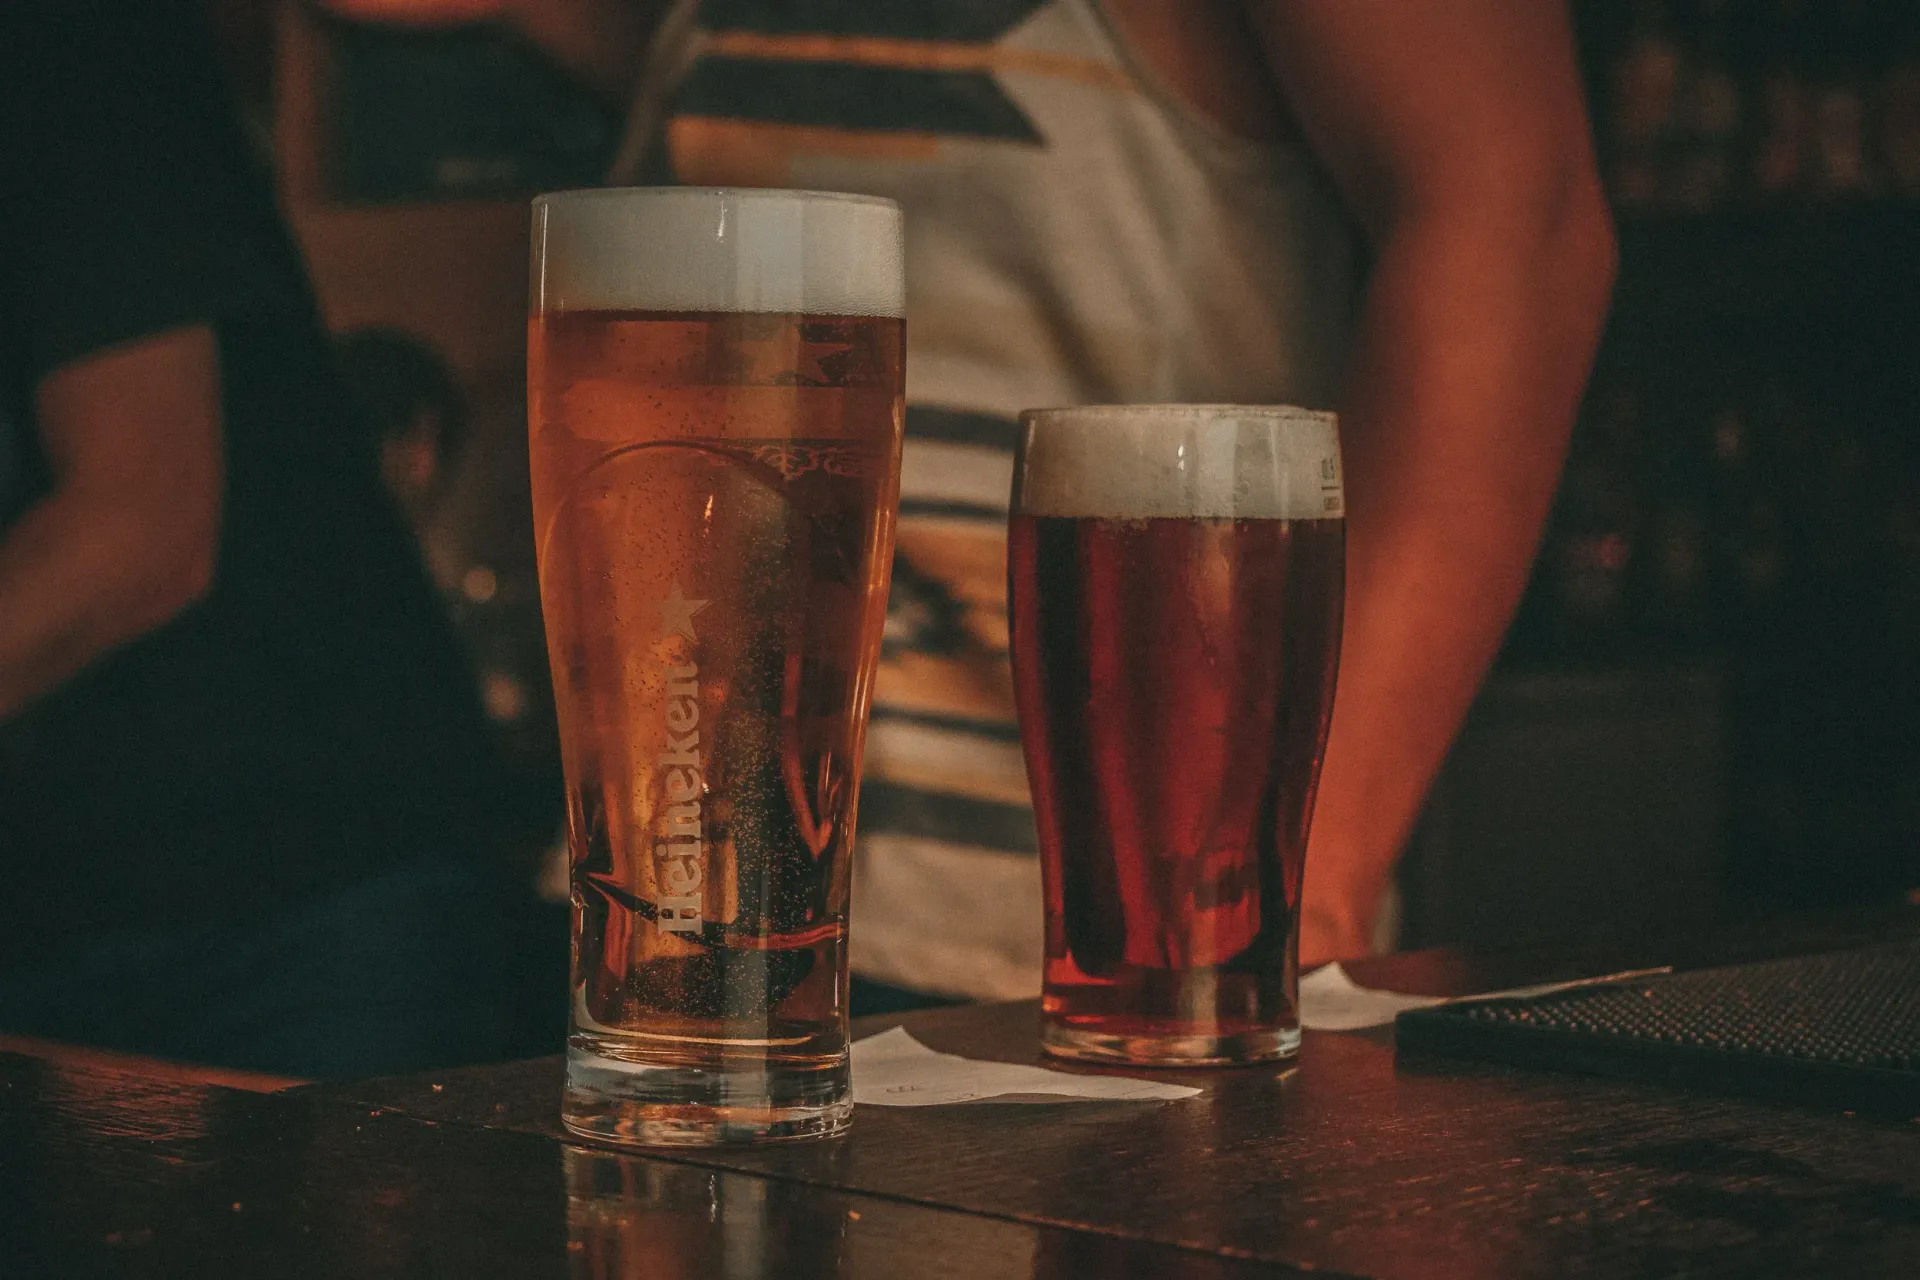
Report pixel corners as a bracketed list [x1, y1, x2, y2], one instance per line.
[852, 1027, 1200, 1107]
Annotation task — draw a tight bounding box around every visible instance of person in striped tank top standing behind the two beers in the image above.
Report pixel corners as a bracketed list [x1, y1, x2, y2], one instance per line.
[332, 0, 1615, 1007]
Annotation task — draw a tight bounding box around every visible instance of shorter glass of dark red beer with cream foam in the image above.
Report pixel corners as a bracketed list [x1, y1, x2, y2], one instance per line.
[1008, 405, 1346, 1065]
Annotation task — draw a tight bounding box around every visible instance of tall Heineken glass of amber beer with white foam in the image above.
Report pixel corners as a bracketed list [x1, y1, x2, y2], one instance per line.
[528, 188, 904, 1144]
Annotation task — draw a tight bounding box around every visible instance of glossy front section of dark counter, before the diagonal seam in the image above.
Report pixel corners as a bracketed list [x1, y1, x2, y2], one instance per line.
[0, 1054, 1294, 1280]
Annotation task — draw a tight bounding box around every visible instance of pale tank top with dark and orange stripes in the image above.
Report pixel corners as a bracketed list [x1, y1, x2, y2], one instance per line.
[614, 0, 1357, 998]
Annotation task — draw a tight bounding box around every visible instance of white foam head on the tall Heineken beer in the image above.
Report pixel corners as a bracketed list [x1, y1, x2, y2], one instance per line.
[532, 186, 906, 317]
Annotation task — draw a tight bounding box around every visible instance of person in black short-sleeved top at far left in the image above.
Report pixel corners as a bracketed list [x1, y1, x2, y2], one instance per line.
[0, 0, 518, 1077]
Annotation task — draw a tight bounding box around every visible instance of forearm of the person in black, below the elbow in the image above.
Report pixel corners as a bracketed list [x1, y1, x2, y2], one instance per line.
[0, 493, 211, 722]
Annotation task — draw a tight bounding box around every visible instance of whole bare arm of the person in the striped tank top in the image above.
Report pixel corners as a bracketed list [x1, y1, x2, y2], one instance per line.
[1250, 0, 1615, 961]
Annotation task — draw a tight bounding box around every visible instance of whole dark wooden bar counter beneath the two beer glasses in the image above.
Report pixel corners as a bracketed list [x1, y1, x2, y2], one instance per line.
[0, 910, 1920, 1280]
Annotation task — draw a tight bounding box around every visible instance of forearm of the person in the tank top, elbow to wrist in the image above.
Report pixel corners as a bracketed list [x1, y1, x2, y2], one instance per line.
[1306, 200, 1613, 954]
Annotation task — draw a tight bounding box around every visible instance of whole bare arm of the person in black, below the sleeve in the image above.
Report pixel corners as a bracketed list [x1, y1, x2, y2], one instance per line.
[0, 324, 223, 720]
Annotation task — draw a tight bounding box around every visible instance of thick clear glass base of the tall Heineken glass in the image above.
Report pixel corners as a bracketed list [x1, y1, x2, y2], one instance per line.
[561, 1044, 852, 1148]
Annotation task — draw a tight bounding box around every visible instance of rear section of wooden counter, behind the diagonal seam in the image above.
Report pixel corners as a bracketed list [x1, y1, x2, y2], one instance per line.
[296, 912, 1920, 1278]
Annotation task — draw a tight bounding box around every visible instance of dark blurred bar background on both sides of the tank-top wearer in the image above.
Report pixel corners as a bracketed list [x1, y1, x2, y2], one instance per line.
[205, 0, 1920, 959]
